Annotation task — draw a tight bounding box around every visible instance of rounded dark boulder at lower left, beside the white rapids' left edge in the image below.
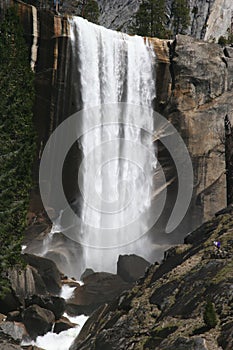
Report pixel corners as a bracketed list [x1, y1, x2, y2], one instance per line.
[23, 305, 55, 339]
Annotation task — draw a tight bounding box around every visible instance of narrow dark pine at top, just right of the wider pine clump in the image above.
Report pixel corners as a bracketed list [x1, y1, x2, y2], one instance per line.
[171, 0, 190, 35]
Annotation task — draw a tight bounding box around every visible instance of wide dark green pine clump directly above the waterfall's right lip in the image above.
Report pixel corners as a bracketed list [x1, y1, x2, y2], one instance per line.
[131, 0, 167, 38]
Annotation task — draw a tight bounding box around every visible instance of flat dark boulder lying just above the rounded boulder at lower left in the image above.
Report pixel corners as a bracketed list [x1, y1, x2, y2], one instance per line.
[25, 295, 65, 320]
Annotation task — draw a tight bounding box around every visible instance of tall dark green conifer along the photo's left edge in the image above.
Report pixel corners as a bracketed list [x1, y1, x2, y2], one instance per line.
[0, 8, 35, 293]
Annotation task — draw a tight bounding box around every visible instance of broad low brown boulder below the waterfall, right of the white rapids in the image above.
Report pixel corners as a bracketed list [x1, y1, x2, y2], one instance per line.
[66, 272, 131, 315]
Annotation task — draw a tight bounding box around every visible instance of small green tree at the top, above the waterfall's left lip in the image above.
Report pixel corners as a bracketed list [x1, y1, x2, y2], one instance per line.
[77, 0, 100, 24]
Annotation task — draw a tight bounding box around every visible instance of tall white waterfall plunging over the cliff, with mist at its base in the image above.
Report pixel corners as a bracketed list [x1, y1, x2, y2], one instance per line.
[39, 17, 177, 278]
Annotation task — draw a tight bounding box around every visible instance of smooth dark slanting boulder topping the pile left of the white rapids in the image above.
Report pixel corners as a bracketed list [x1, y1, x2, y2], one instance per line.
[23, 254, 61, 294]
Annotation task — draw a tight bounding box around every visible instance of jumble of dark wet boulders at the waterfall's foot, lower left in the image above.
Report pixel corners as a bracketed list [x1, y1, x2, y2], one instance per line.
[0, 245, 149, 350]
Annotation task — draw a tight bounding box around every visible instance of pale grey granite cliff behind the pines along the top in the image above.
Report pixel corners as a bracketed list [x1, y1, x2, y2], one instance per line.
[97, 0, 233, 41]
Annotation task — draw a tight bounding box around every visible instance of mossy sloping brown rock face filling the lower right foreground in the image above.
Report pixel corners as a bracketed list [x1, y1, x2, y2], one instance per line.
[70, 208, 233, 350]
